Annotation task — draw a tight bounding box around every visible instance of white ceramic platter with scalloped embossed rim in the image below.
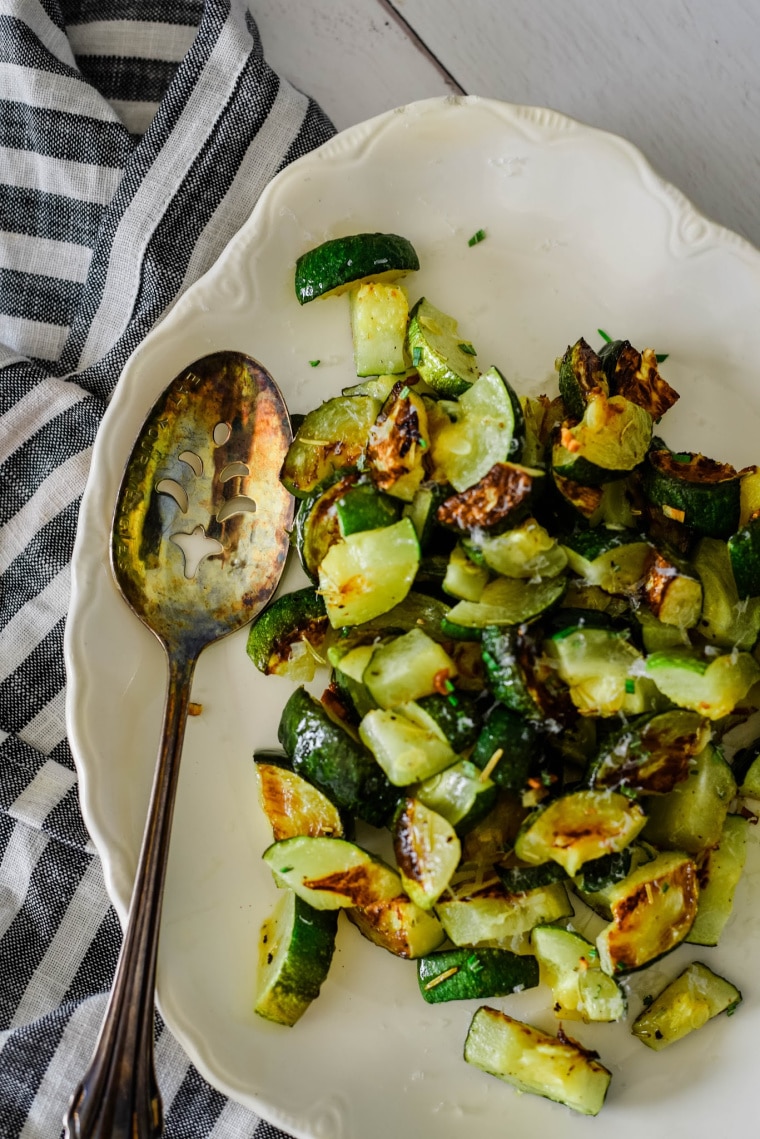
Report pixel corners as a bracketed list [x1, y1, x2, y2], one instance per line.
[66, 98, 760, 1139]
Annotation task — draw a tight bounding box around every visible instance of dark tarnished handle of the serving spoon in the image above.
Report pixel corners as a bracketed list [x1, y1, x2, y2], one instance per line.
[64, 653, 195, 1139]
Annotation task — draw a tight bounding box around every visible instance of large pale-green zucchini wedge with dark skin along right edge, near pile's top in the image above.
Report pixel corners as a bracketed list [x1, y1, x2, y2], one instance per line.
[433, 368, 525, 491]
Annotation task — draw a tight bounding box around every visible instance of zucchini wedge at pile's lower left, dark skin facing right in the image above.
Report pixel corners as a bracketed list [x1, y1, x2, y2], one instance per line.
[254, 890, 337, 1026]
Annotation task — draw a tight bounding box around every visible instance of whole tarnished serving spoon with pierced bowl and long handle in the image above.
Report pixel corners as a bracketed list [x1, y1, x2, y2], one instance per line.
[64, 352, 293, 1139]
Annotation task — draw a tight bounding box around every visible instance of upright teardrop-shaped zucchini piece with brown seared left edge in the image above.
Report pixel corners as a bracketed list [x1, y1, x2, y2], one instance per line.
[393, 797, 461, 910]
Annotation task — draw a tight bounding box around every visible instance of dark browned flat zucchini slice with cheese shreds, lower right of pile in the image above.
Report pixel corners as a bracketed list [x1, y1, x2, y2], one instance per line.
[588, 708, 711, 794]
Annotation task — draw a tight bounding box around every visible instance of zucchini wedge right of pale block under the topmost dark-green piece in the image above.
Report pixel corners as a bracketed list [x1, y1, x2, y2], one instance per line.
[407, 297, 479, 398]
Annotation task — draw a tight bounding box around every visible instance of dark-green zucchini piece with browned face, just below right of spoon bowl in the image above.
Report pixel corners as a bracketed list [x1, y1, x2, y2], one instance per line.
[246, 588, 329, 681]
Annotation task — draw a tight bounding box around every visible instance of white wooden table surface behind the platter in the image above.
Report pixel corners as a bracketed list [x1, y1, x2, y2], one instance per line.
[250, 0, 760, 245]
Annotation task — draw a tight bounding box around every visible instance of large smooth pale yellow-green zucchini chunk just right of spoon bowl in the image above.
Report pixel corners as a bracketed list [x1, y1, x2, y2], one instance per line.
[319, 518, 419, 629]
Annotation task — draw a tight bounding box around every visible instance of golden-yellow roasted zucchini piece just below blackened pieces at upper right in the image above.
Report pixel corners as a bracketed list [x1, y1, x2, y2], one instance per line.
[551, 391, 652, 486]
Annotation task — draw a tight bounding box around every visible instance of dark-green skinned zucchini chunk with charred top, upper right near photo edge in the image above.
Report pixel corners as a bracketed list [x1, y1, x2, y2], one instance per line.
[644, 450, 741, 538]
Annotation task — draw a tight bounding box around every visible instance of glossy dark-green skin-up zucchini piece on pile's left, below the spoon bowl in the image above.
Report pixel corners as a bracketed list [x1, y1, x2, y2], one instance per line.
[278, 688, 399, 827]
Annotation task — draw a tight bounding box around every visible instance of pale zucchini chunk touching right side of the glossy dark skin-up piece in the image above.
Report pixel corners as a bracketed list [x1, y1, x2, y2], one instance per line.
[359, 704, 456, 787]
